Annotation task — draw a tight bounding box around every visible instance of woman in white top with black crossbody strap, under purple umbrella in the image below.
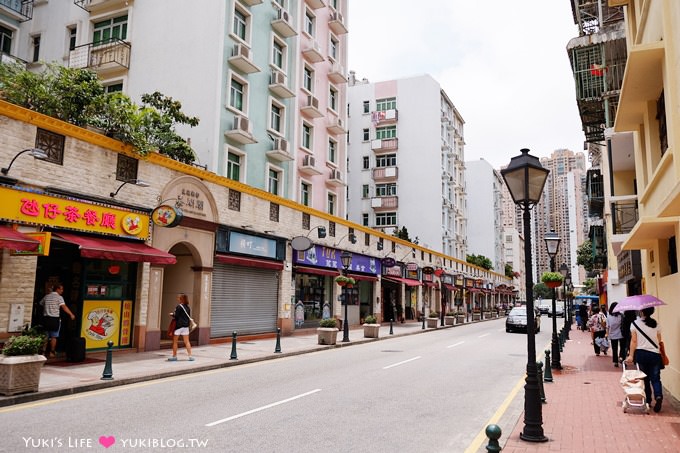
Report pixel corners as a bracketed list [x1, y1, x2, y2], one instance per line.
[626, 307, 663, 412]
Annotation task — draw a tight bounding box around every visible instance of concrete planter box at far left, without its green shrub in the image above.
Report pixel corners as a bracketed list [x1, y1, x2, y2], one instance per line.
[0, 354, 47, 395]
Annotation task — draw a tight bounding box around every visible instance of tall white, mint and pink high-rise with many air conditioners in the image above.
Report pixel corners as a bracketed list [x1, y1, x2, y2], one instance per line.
[0, 0, 348, 216]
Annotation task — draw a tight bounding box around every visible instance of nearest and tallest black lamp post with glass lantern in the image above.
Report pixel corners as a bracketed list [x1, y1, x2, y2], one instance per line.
[501, 148, 550, 442]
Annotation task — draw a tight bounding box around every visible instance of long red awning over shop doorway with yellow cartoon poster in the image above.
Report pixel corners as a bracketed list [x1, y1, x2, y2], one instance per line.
[54, 233, 177, 264]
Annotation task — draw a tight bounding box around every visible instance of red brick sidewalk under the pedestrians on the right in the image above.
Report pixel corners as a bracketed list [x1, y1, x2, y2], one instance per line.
[500, 328, 680, 453]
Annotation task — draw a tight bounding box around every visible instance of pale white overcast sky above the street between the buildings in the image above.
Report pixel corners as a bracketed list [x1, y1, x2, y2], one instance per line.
[347, 0, 585, 169]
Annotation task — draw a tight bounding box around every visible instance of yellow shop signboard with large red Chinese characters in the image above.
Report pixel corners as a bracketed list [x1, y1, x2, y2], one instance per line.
[0, 187, 149, 239]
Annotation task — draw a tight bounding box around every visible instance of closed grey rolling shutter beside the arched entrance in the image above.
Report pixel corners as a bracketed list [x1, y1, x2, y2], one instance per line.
[210, 263, 279, 338]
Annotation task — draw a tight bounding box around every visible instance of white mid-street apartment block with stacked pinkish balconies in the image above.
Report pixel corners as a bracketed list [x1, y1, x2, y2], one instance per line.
[347, 72, 467, 261]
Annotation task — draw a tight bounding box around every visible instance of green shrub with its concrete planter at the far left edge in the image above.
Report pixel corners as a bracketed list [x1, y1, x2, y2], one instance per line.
[0, 327, 47, 395]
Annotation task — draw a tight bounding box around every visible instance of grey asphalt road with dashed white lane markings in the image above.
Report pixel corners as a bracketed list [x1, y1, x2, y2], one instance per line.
[0, 318, 550, 452]
